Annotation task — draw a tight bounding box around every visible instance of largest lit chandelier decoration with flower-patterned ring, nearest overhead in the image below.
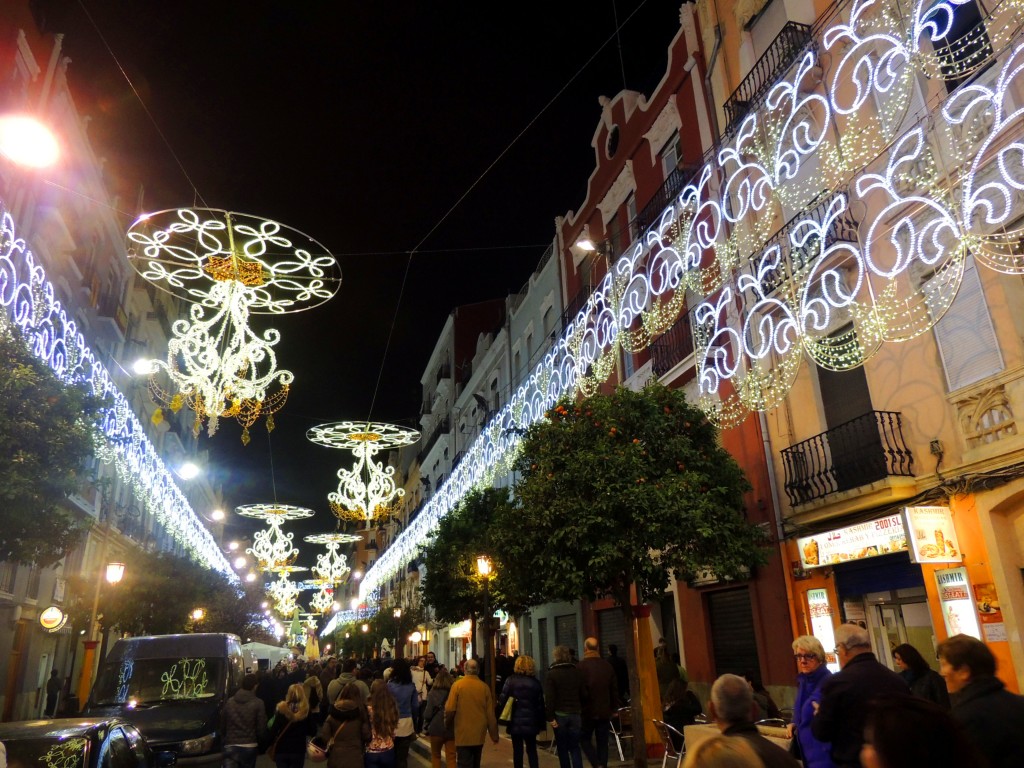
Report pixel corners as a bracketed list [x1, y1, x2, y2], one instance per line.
[127, 208, 341, 443]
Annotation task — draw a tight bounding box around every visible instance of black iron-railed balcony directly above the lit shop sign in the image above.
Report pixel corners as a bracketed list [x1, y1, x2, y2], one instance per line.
[780, 411, 913, 507]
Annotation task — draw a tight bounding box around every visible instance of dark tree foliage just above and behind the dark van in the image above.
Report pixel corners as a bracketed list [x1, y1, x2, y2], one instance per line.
[99, 551, 270, 642]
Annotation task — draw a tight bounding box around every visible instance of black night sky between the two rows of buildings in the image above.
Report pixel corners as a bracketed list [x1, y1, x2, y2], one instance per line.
[40, 0, 679, 560]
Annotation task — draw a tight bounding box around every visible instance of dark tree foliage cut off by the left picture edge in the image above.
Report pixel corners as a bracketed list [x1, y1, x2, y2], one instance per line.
[0, 326, 99, 565]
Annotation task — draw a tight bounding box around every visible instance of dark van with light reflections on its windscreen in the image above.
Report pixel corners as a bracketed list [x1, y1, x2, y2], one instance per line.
[83, 633, 245, 766]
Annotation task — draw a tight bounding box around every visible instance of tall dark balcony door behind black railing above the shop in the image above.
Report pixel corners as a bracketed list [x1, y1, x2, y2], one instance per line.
[818, 328, 886, 490]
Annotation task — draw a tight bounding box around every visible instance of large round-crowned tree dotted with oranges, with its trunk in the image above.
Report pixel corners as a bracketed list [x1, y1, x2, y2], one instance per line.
[489, 384, 766, 765]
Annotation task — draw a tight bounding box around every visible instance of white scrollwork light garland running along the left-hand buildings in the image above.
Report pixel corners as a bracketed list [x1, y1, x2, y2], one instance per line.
[0, 203, 238, 582]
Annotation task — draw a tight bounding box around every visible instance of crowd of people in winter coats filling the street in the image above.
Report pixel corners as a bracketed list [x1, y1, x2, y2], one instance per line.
[223, 624, 1024, 768]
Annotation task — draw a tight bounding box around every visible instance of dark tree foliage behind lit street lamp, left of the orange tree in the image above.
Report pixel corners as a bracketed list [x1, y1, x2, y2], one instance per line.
[421, 488, 527, 624]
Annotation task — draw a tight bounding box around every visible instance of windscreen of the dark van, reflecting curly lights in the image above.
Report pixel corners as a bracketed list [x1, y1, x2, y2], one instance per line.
[92, 656, 225, 705]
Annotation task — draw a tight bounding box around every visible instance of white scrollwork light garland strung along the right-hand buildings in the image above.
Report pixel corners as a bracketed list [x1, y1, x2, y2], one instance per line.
[360, 0, 1024, 597]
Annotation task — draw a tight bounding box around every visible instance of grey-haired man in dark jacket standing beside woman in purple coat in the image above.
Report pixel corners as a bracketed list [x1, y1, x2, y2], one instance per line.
[811, 624, 910, 768]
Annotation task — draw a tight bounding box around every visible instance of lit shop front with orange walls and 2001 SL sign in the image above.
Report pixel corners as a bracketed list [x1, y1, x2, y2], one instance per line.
[787, 506, 1016, 689]
